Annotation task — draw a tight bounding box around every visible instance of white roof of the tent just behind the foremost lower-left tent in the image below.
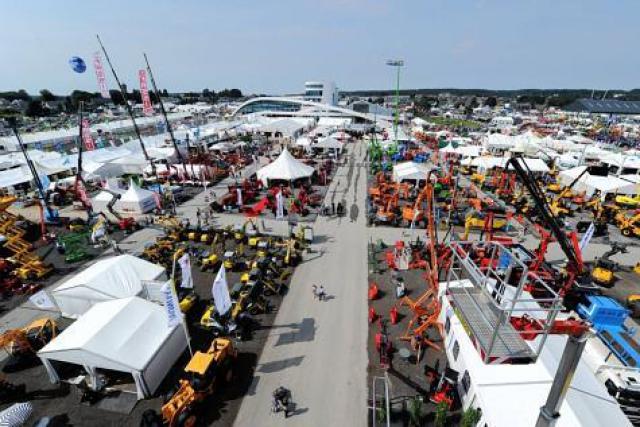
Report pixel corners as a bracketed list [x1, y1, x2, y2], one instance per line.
[53, 255, 164, 298]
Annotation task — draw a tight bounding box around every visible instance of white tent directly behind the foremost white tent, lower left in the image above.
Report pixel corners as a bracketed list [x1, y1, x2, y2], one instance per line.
[51, 255, 165, 318]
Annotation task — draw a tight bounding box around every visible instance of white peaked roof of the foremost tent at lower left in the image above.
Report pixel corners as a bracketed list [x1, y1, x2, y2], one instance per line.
[38, 297, 179, 372]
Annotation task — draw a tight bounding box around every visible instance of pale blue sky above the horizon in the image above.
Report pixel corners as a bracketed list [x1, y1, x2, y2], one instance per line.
[0, 0, 640, 94]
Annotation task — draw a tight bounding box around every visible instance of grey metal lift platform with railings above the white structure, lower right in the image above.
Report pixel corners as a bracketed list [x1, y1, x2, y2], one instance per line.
[446, 241, 563, 363]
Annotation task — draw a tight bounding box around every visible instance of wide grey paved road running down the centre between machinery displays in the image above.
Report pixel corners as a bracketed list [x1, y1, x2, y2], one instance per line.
[235, 143, 367, 426]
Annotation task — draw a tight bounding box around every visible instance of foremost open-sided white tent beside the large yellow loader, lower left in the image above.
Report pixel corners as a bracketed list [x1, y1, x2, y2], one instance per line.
[38, 297, 187, 399]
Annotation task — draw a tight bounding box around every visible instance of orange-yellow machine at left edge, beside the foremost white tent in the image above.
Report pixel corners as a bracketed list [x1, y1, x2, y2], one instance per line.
[0, 318, 58, 357]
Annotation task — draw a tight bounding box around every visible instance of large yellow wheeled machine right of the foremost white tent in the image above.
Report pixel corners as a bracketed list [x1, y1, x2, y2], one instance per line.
[162, 338, 237, 427]
